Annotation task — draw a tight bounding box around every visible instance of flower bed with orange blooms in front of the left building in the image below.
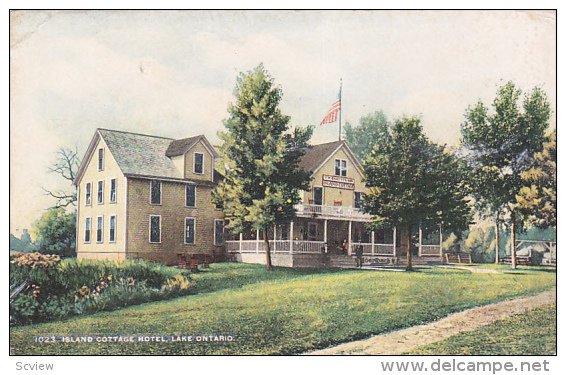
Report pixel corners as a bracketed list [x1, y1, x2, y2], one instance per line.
[10, 253, 190, 325]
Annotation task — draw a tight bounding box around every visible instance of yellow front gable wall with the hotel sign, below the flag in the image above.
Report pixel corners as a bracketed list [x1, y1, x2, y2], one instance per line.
[303, 148, 367, 207]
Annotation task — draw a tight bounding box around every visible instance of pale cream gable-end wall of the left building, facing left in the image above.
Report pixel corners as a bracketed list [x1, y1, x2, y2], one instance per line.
[77, 139, 126, 260]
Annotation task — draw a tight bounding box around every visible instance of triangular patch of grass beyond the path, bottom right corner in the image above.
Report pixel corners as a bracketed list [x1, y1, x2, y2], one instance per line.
[407, 303, 556, 355]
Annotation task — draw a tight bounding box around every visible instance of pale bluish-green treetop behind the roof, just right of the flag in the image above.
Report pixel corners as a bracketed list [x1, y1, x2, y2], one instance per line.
[344, 111, 389, 160]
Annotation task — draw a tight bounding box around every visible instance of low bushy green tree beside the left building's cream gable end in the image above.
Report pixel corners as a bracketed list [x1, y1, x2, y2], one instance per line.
[33, 207, 76, 256]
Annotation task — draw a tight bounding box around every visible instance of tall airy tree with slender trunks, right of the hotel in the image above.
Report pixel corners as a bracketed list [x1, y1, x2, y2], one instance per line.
[462, 82, 550, 268]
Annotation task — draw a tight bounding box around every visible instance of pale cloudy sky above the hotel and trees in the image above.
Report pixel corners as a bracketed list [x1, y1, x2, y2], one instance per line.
[10, 11, 556, 235]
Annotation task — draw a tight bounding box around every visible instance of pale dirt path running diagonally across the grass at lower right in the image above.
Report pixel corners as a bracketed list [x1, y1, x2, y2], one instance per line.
[305, 290, 556, 355]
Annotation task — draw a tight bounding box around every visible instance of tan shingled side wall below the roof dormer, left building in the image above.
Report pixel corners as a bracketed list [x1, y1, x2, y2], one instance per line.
[127, 178, 223, 264]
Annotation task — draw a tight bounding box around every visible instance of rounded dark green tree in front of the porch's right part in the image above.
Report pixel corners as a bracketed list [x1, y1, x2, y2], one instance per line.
[363, 117, 471, 270]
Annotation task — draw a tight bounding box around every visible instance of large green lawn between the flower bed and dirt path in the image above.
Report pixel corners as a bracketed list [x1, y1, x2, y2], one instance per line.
[10, 263, 556, 355]
